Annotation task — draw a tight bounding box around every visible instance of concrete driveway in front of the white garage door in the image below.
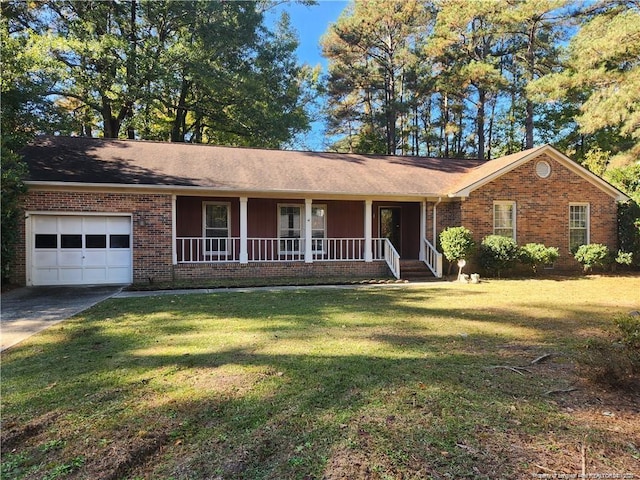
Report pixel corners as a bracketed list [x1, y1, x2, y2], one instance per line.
[0, 285, 123, 351]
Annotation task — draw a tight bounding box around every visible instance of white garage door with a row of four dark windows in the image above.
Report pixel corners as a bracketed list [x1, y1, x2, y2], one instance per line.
[31, 215, 132, 285]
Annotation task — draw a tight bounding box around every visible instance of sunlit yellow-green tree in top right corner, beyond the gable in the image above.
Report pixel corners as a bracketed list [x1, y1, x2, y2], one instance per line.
[530, 1, 640, 165]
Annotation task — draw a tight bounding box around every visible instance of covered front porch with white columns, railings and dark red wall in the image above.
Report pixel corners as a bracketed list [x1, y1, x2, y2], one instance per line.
[173, 196, 442, 278]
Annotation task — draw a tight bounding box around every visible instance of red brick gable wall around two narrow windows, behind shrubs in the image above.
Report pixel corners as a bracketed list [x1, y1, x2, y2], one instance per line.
[458, 156, 617, 268]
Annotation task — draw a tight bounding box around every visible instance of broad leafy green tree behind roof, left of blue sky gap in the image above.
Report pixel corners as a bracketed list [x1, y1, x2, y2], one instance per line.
[25, 0, 308, 146]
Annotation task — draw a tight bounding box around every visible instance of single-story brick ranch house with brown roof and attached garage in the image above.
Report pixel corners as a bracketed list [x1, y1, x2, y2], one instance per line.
[12, 137, 627, 285]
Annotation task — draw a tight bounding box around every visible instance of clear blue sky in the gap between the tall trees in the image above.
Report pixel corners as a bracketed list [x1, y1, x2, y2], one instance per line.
[269, 0, 349, 151]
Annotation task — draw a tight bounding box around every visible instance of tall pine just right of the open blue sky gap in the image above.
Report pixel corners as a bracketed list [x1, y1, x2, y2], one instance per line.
[322, 0, 425, 154]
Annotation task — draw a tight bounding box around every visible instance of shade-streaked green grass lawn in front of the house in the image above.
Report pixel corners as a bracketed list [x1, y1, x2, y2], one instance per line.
[2, 277, 640, 479]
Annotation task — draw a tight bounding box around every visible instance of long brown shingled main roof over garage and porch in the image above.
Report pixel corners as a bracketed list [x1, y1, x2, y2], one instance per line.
[22, 137, 486, 196]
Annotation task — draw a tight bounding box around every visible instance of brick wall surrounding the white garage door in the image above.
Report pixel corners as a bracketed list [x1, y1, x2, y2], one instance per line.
[12, 191, 172, 284]
